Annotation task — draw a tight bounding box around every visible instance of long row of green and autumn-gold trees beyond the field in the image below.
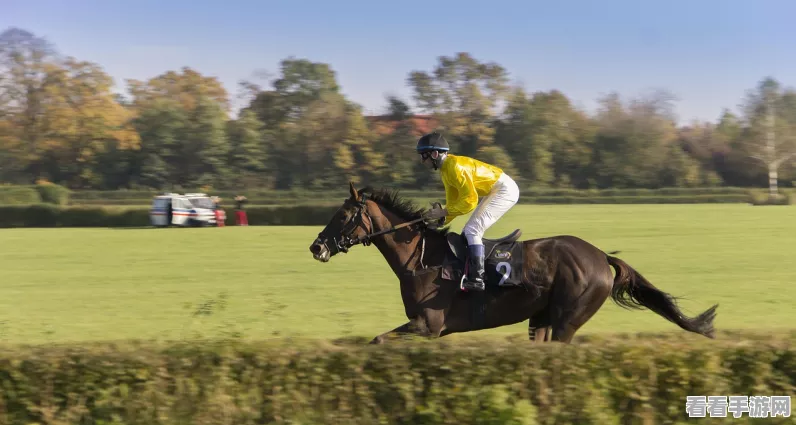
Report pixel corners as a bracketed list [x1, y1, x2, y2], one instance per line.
[0, 28, 796, 190]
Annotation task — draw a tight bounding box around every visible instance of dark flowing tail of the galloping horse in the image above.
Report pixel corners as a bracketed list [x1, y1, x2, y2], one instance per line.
[606, 255, 718, 338]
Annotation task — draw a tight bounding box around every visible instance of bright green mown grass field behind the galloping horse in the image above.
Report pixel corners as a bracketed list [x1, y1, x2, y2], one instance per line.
[0, 205, 796, 343]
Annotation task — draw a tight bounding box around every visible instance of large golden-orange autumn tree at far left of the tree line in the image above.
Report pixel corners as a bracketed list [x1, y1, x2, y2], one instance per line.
[0, 28, 138, 187]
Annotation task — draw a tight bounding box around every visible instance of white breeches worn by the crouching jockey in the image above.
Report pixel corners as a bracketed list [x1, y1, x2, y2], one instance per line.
[462, 173, 520, 245]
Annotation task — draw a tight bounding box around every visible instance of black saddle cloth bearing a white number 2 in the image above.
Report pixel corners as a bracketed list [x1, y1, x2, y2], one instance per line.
[442, 229, 524, 288]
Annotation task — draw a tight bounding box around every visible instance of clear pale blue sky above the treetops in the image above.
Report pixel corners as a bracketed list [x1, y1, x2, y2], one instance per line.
[6, 0, 796, 122]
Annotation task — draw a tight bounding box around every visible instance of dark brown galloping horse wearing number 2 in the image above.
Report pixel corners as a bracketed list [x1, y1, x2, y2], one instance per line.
[310, 184, 718, 343]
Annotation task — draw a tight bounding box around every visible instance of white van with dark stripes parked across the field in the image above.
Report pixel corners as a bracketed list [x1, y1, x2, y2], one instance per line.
[149, 193, 216, 227]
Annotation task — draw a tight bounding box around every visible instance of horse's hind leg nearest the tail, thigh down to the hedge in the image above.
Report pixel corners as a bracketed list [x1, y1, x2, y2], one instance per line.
[551, 278, 613, 344]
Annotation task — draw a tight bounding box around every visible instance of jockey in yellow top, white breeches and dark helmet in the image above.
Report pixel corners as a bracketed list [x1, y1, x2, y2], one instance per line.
[417, 132, 520, 291]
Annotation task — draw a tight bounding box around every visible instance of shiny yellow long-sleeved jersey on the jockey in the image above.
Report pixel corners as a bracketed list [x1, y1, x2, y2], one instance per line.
[440, 154, 503, 224]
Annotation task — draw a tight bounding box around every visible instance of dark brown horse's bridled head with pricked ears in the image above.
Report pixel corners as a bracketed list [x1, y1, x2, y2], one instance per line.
[310, 183, 373, 263]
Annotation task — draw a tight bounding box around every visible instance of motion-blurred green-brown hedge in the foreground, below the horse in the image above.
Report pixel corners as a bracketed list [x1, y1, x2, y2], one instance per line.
[0, 338, 796, 425]
